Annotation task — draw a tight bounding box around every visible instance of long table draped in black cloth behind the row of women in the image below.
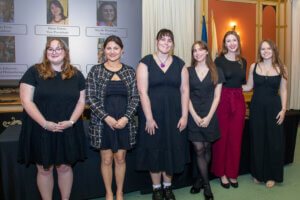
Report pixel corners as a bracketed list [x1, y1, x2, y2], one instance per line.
[0, 111, 300, 200]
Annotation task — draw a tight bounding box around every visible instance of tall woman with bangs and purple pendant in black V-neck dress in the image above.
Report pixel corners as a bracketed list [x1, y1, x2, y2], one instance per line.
[137, 29, 189, 200]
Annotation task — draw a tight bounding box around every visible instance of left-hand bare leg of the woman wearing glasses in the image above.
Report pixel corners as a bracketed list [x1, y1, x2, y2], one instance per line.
[36, 164, 54, 200]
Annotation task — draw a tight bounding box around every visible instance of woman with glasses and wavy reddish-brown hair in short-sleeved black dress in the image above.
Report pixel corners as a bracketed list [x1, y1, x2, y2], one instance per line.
[19, 39, 85, 200]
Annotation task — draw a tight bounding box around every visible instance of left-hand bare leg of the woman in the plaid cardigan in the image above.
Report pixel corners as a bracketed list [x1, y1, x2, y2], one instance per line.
[100, 150, 114, 200]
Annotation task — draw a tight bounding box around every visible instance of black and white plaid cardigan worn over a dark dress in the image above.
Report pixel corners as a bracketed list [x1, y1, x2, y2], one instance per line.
[86, 63, 139, 149]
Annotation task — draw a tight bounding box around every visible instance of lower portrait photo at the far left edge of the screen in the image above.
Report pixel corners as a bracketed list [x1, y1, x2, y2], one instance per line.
[0, 36, 16, 63]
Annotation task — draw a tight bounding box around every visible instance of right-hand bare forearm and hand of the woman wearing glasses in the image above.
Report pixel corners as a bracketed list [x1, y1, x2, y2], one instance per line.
[58, 90, 85, 129]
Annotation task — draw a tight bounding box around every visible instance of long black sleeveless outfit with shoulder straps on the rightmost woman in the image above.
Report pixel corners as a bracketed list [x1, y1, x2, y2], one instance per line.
[250, 63, 284, 182]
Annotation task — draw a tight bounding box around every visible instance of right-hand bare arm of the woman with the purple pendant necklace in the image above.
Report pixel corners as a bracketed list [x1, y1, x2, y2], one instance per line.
[177, 66, 190, 132]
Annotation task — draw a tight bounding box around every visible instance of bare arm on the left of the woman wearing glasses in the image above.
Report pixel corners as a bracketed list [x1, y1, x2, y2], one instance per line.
[20, 83, 62, 132]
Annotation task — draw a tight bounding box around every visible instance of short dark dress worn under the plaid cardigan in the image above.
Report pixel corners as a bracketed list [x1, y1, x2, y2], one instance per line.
[101, 81, 131, 152]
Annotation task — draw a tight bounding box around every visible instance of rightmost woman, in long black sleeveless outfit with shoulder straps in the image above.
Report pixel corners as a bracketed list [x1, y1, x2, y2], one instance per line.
[243, 40, 287, 187]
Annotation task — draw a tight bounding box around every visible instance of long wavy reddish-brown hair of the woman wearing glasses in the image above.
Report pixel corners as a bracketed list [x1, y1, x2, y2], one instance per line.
[36, 38, 77, 80]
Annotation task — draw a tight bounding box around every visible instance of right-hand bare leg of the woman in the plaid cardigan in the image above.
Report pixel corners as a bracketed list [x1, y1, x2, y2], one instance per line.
[114, 150, 126, 200]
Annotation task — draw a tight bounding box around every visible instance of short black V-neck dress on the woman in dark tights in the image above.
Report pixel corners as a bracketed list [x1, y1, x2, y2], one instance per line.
[188, 67, 224, 142]
